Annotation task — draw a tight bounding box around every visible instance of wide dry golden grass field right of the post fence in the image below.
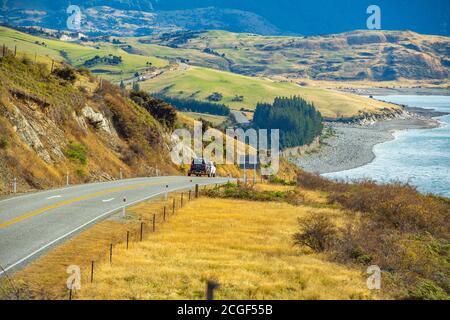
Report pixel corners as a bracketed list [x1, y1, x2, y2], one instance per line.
[76, 199, 375, 299]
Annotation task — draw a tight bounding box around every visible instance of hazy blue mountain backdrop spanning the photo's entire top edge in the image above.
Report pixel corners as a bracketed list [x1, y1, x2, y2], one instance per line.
[0, 0, 450, 36]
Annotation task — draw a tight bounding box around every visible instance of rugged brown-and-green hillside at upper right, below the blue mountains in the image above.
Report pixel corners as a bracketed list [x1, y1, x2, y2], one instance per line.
[147, 30, 450, 82]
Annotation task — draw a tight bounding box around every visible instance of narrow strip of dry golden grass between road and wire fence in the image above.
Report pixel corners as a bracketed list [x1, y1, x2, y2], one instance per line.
[14, 193, 188, 299]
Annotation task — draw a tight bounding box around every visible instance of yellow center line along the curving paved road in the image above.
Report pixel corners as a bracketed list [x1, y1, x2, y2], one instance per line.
[0, 180, 178, 229]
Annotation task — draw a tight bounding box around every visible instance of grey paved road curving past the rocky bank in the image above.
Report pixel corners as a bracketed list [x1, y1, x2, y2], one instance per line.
[0, 177, 228, 276]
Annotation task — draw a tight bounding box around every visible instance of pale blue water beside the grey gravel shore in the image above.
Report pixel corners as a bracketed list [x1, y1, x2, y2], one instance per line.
[324, 96, 450, 197]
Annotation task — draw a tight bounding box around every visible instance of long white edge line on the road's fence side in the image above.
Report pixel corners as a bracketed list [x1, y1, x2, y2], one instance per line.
[0, 179, 230, 276]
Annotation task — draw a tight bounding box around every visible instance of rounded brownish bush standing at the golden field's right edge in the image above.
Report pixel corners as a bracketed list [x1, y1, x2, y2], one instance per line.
[294, 214, 337, 252]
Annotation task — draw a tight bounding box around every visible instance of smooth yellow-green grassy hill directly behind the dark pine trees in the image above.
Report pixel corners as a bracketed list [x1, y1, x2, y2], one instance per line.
[141, 67, 394, 118]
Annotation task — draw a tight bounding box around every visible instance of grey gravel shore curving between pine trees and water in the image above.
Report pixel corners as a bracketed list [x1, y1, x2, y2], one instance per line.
[290, 118, 439, 174]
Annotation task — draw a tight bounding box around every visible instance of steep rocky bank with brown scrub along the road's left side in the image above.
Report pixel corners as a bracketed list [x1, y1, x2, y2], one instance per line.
[0, 57, 177, 194]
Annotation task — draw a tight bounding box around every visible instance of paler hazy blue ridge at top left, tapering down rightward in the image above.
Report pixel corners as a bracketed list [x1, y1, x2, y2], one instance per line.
[0, 1, 281, 36]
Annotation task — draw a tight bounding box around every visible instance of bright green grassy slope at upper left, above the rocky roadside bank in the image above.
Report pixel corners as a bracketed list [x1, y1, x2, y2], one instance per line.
[0, 27, 168, 80]
